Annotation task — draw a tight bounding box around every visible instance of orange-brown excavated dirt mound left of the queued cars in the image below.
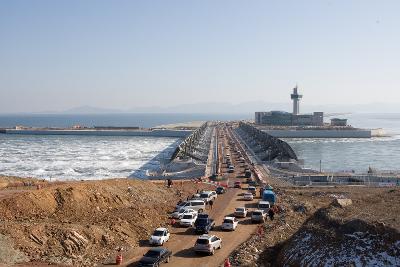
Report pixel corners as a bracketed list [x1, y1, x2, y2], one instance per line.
[0, 179, 209, 266]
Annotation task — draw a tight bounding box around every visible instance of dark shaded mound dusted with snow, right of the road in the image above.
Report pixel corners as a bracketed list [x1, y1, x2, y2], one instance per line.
[276, 205, 400, 266]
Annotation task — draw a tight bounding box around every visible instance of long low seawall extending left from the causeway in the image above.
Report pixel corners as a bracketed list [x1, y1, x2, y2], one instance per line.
[2, 129, 192, 138]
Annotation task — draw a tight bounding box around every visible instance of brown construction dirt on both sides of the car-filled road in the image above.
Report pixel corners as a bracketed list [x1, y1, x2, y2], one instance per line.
[0, 177, 400, 266]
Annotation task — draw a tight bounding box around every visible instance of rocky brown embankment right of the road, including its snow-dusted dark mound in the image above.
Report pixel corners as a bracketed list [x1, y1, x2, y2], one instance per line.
[230, 187, 400, 266]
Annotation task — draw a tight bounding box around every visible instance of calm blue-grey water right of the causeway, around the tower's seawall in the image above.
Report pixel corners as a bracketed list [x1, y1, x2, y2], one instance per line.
[285, 113, 400, 173]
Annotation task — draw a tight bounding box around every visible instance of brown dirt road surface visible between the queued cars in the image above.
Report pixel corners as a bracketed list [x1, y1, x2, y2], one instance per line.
[119, 126, 259, 267]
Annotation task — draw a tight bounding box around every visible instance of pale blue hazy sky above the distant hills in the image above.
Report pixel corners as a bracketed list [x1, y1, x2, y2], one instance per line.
[0, 0, 400, 112]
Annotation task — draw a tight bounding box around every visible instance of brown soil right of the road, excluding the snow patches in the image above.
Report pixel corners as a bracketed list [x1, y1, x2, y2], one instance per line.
[230, 178, 400, 266]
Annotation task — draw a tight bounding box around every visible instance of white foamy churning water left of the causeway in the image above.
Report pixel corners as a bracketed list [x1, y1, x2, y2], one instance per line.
[0, 135, 177, 180]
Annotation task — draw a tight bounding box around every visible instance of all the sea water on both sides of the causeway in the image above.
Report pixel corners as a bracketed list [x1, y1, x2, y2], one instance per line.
[0, 113, 400, 180]
